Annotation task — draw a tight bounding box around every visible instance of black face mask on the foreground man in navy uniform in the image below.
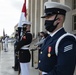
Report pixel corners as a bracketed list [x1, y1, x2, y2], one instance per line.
[45, 15, 59, 32]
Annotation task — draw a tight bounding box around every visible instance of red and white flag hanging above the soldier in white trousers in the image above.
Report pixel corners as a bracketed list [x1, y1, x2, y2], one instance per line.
[18, 0, 27, 27]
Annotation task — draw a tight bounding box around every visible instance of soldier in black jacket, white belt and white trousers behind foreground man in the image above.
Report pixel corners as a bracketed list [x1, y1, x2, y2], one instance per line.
[16, 21, 32, 75]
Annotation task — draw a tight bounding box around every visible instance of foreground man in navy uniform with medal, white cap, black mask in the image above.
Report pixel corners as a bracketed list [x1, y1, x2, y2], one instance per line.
[38, 1, 76, 75]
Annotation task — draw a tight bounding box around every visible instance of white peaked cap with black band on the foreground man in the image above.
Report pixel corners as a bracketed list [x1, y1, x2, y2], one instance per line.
[42, 1, 71, 18]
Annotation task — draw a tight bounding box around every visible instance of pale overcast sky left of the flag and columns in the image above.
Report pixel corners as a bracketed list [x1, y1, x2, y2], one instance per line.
[0, 0, 27, 36]
